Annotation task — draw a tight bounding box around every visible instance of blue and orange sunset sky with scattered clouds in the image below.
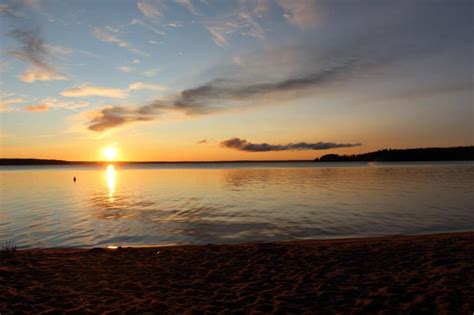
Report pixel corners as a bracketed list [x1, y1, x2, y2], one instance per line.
[0, 0, 474, 161]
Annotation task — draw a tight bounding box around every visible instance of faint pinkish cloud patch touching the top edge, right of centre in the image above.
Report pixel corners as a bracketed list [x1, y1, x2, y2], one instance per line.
[278, 0, 318, 30]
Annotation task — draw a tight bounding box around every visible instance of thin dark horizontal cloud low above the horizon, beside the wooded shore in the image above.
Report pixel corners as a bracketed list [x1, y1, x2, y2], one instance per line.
[220, 138, 361, 152]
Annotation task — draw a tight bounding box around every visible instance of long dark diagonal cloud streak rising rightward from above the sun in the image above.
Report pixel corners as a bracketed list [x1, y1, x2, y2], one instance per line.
[84, 58, 362, 131]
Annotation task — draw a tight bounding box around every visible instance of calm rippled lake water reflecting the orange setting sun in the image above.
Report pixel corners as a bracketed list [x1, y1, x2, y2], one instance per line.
[0, 163, 474, 247]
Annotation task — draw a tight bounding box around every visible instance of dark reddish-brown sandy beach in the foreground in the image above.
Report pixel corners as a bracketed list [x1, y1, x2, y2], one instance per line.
[0, 233, 474, 314]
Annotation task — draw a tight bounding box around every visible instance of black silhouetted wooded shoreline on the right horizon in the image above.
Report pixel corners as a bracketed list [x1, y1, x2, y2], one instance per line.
[315, 146, 474, 162]
